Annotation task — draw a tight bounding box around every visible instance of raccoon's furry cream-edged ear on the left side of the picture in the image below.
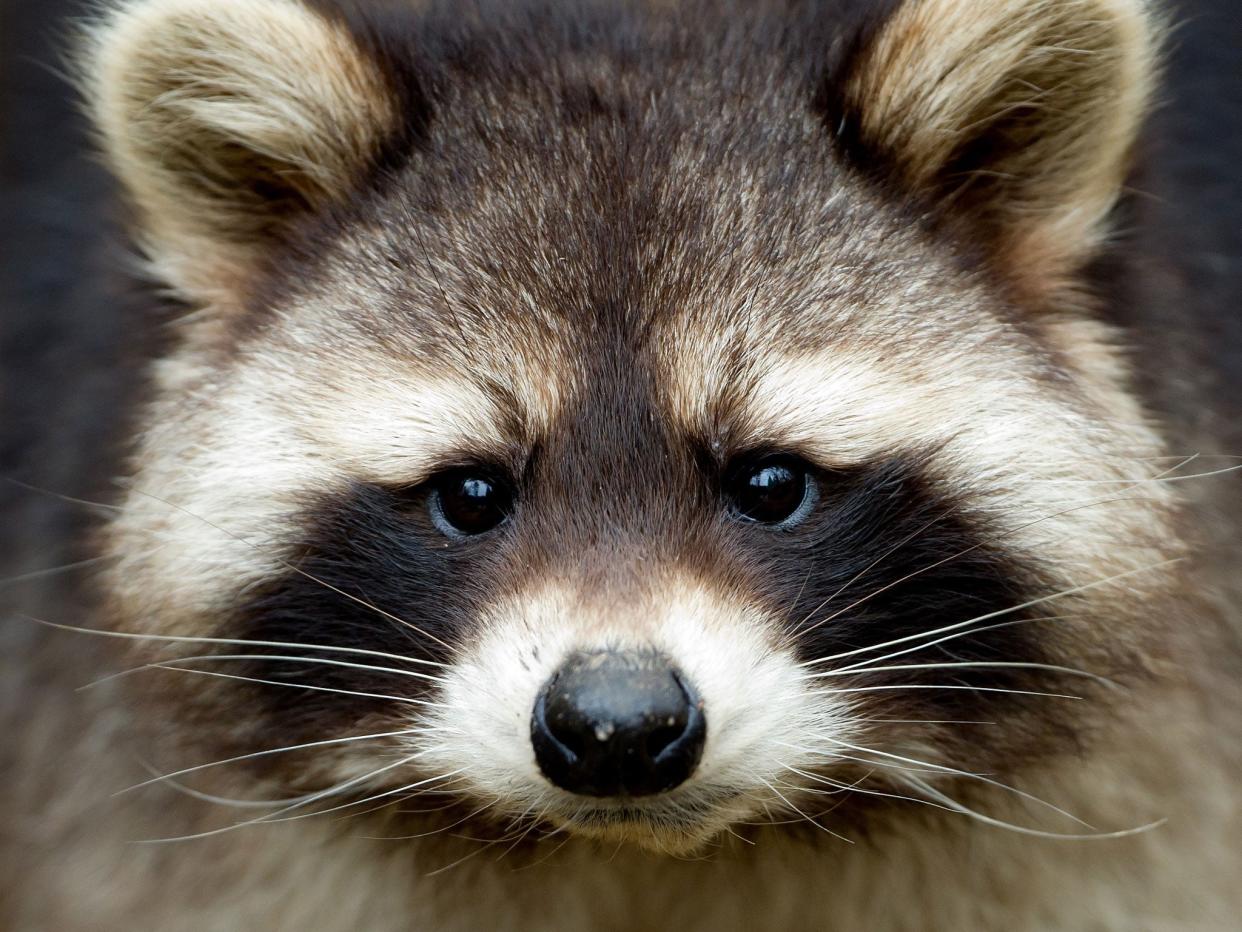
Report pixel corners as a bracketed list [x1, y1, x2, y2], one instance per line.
[82, 0, 399, 292]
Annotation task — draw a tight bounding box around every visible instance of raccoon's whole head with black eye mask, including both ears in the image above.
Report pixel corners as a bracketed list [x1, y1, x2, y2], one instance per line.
[86, 0, 1180, 851]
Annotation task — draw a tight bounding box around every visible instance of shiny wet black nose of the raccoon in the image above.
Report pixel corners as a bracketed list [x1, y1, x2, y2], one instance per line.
[530, 651, 707, 797]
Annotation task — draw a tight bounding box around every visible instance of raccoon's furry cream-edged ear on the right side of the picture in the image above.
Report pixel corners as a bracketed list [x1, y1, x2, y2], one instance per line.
[835, 0, 1156, 281]
